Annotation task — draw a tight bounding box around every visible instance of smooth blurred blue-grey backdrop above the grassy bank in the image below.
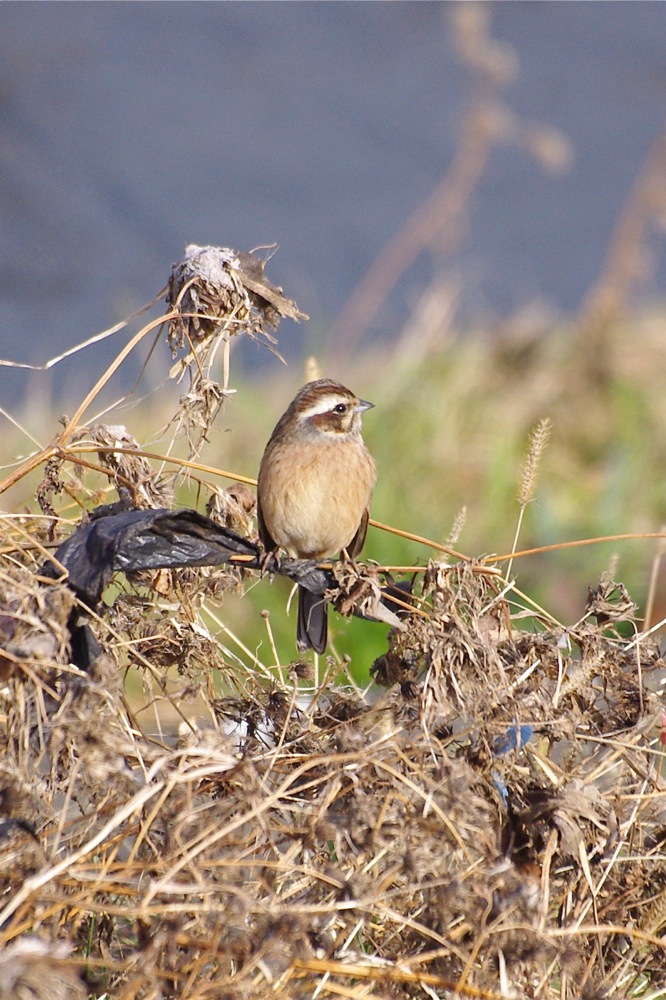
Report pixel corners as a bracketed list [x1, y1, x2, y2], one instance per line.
[0, 2, 666, 399]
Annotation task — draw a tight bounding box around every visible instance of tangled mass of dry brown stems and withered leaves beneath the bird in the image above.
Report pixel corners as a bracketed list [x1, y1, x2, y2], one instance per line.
[0, 248, 666, 1000]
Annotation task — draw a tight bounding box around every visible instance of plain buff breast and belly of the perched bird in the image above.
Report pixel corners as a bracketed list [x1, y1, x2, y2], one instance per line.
[259, 441, 375, 559]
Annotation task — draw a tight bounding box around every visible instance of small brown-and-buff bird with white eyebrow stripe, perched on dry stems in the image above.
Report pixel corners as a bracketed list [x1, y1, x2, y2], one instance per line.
[257, 378, 377, 653]
